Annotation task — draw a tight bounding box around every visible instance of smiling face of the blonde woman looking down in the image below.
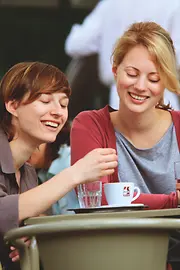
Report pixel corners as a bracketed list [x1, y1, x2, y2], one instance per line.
[113, 45, 164, 113]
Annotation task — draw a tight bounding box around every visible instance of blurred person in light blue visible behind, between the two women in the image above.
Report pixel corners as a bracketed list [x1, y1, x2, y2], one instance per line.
[28, 122, 79, 215]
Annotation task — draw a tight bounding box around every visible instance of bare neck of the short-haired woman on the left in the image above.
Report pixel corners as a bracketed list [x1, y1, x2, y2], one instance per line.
[10, 137, 38, 171]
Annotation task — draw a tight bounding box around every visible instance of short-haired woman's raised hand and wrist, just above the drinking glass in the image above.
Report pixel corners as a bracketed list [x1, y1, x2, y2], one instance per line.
[73, 148, 118, 185]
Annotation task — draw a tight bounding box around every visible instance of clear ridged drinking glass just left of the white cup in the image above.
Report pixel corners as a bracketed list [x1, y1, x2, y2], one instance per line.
[77, 181, 102, 208]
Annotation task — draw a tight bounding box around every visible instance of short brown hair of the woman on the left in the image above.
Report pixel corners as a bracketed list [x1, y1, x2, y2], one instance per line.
[0, 62, 71, 140]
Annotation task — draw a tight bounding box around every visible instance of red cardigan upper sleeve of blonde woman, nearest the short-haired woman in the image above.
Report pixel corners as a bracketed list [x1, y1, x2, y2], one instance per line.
[70, 112, 108, 187]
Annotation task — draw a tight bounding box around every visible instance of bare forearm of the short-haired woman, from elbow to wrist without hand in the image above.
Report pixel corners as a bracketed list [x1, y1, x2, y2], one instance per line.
[19, 167, 78, 222]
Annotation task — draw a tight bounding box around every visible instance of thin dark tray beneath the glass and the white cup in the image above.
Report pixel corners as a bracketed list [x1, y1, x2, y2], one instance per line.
[68, 203, 148, 214]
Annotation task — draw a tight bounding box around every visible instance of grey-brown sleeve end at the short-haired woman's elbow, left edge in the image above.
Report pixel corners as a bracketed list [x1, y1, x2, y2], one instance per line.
[0, 183, 19, 234]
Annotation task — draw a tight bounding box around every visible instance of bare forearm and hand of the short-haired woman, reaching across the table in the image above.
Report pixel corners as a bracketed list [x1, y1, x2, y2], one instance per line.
[19, 148, 117, 221]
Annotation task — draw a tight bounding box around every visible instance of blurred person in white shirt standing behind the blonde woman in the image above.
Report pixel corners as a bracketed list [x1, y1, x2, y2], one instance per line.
[65, 0, 180, 110]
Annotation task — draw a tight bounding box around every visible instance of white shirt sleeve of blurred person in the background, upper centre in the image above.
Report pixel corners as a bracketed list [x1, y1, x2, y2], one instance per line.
[65, 0, 106, 57]
